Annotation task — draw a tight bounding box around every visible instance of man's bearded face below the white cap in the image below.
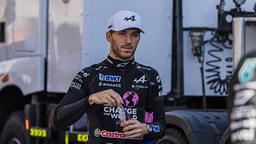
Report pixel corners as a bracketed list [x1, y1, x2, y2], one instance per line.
[106, 28, 140, 60]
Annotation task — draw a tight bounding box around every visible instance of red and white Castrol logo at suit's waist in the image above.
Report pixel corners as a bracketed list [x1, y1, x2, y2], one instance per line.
[94, 129, 127, 139]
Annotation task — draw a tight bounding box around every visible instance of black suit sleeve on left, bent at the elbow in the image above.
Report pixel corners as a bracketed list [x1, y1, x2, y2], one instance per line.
[54, 70, 90, 128]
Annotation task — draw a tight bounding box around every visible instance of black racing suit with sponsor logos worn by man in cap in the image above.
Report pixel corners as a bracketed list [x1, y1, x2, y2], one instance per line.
[54, 56, 165, 144]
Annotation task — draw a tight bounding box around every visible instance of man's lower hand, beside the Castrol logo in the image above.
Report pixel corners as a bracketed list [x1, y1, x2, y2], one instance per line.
[121, 119, 149, 139]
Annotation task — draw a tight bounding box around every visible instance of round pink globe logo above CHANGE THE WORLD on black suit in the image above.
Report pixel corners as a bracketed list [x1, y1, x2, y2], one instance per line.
[123, 91, 139, 107]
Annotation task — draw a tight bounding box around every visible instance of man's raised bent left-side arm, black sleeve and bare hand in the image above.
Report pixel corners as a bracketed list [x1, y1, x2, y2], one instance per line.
[54, 68, 123, 127]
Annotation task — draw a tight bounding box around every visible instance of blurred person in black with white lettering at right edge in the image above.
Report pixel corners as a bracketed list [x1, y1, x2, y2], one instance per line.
[228, 50, 256, 144]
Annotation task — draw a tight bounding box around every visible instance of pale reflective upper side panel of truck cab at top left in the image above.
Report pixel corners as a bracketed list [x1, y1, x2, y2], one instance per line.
[6, 0, 42, 58]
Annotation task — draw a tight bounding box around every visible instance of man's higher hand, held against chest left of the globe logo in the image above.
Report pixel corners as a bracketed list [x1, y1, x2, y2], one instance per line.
[88, 89, 123, 107]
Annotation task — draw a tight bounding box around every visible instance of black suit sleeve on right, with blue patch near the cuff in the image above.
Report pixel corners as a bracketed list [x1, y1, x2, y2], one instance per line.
[146, 71, 166, 139]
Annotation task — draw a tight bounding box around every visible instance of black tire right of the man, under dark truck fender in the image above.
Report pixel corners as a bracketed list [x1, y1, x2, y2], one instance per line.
[156, 128, 188, 144]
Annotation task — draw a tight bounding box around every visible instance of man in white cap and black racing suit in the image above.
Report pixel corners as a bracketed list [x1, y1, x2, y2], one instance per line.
[54, 10, 165, 144]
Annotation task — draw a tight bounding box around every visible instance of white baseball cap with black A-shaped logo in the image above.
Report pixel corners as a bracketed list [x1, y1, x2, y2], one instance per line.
[107, 10, 144, 32]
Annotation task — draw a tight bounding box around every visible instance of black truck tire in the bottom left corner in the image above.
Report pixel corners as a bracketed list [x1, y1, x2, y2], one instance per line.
[0, 112, 30, 144]
